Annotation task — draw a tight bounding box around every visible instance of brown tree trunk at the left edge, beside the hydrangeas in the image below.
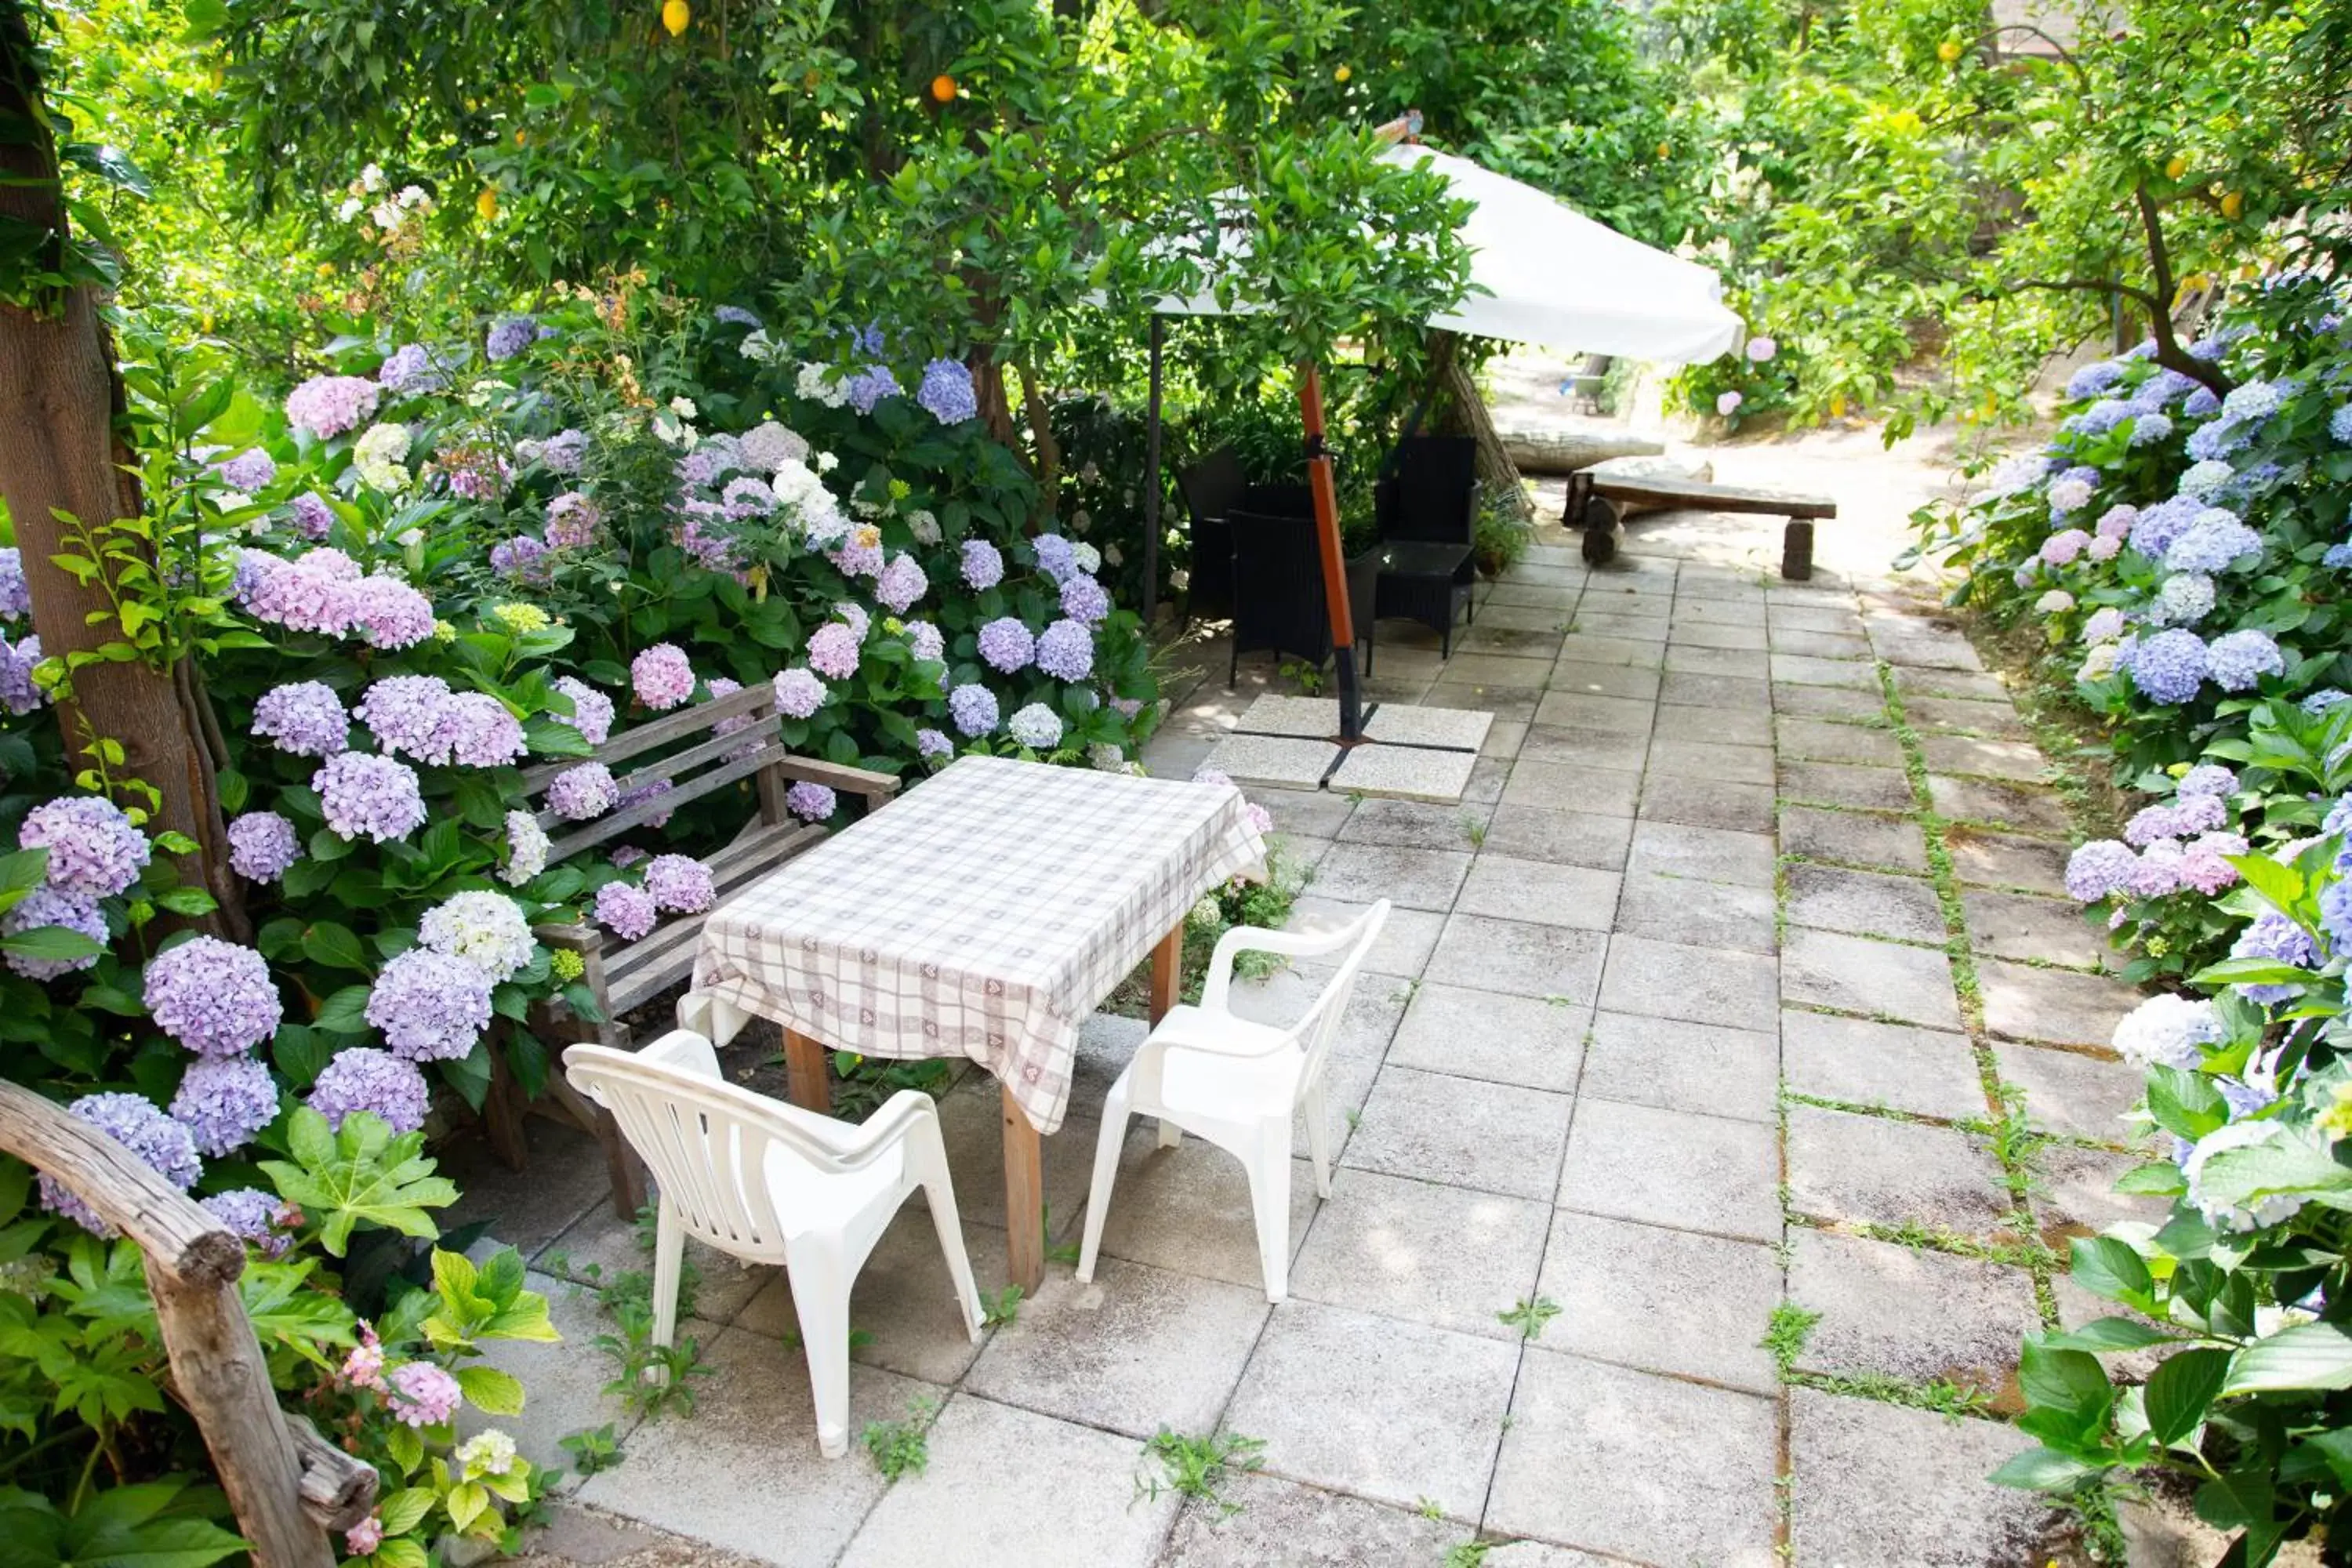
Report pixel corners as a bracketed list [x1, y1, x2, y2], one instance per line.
[0, 16, 235, 909]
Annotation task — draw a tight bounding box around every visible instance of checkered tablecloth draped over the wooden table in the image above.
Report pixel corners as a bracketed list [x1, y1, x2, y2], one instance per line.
[680, 757, 1265, 1133]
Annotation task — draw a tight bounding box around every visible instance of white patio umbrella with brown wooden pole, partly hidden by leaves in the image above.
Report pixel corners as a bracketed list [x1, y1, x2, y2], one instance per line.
[1143, 124, 1743, 741]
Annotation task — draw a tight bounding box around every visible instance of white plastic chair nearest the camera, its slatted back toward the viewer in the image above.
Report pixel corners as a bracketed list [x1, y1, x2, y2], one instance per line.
[564, 1029, 981, 1460]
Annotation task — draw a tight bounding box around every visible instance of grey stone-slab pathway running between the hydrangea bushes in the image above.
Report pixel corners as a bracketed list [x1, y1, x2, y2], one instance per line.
[468, 520, 2138, 1568]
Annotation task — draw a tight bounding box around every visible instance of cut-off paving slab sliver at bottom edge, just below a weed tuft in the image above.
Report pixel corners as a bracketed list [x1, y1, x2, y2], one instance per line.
[1160, 1472, 1458, 1568]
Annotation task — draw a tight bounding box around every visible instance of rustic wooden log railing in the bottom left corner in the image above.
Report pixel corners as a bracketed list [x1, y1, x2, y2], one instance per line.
[0, 1081, 379, 1568]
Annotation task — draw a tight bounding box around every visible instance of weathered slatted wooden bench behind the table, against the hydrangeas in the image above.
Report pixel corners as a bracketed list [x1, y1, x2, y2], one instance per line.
[499, 682, 898, 1218]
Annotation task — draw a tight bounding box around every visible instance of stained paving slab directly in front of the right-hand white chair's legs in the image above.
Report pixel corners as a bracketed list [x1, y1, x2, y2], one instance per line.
[964, 1258, 1268, 1441]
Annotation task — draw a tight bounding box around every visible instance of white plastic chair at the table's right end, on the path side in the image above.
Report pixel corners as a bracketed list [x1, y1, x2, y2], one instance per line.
[1077, 898, 1388, 1302]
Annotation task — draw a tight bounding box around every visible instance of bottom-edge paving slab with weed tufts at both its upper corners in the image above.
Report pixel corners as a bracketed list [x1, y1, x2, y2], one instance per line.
[1486, 1347, 1778, 1568]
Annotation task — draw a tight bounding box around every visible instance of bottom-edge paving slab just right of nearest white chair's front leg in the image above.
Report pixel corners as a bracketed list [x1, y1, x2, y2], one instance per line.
[842, 1394, 1181, 1568]
